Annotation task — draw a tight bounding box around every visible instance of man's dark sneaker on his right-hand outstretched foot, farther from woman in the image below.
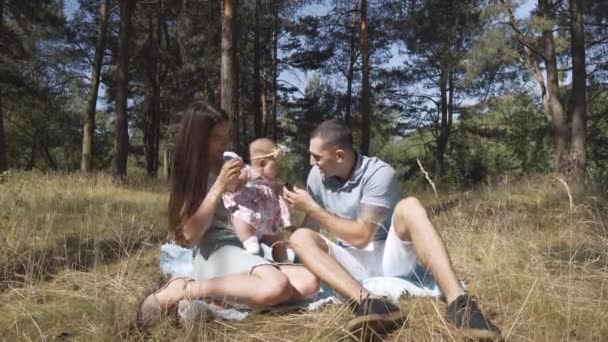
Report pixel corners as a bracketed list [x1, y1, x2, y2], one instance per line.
[446, 294, 500, 339]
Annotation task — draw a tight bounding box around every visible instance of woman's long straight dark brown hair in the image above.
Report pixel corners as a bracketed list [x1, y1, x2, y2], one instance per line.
[168, 100, 229, 244]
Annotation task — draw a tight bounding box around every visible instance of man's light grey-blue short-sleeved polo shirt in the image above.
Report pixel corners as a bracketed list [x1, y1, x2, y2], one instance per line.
[306, 153, 401, 245]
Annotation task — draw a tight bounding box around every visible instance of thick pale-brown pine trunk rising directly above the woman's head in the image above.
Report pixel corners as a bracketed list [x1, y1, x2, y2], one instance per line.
[220, 0, 240, 149]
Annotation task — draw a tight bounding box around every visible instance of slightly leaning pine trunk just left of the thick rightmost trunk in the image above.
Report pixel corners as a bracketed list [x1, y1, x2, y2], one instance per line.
[539, 0, 568, 175]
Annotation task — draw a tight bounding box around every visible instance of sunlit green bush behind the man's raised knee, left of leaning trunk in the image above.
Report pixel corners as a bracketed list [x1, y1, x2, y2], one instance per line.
[451, 93, 553, 184]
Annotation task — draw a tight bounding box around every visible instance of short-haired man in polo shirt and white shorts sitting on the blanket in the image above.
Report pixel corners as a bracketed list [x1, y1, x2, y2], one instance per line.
[283, 120, 500, 338]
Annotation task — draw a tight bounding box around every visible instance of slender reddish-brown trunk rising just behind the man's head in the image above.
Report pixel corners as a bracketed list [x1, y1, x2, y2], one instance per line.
[361, 0, 371, 154]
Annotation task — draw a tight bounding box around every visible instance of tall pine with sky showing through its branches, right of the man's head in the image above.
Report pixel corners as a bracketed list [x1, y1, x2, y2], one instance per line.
[401, 0, 479, 181]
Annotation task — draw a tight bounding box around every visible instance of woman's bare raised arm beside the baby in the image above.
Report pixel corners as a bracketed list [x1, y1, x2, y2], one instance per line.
[183, 159, 243, 245]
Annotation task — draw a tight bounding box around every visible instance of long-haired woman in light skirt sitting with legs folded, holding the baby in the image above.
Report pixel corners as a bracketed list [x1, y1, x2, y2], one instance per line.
[137, 101, 319, 324]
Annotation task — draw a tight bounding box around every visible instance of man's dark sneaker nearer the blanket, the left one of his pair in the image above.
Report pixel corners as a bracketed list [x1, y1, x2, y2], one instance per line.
[344, 297, 405, 340]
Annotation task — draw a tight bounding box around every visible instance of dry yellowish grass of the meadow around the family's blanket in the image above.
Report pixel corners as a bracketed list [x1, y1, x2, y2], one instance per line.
[0, 173, 608, 341]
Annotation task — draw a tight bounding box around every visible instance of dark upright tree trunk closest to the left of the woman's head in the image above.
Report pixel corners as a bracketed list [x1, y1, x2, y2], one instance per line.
[144, 13, 162, 177]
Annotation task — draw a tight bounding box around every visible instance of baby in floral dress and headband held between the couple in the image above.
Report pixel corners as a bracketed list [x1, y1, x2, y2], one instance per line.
[222, 138, 291, 262]
